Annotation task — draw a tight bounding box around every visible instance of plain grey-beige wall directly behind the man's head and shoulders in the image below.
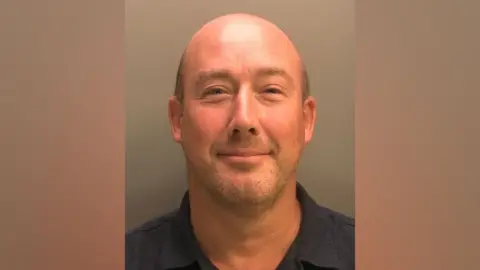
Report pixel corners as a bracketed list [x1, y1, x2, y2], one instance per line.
[126, 0, 355, 231]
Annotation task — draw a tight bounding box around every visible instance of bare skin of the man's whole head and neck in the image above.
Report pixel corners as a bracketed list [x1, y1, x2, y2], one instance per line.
[169, 14, 316, 269]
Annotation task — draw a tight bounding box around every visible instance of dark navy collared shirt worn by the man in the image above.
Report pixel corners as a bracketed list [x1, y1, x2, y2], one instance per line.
[125, 184, 355, 270]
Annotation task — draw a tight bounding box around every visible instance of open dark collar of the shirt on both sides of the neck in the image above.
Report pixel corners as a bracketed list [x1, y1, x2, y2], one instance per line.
[160, 183, 341, 269]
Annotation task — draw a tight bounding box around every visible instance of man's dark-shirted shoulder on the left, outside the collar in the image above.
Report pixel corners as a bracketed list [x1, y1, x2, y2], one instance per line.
[125, 210, 178, 269]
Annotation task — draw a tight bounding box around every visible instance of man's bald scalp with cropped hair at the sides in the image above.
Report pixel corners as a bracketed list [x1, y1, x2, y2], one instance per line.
[175, 13, 310, 103]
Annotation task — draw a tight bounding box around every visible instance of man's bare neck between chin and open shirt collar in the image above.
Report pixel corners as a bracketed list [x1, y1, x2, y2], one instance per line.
[189, 181, 301, 269]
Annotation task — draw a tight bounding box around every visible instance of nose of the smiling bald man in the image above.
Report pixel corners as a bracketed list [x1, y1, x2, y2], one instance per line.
[229, 86, 259, 138]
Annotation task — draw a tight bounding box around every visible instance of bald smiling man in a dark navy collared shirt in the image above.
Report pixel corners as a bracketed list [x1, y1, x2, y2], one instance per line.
[126, 14, 354, 270]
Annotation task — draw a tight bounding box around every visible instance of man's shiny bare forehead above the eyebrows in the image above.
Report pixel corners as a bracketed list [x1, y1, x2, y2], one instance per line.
[187, 23, 300, 79]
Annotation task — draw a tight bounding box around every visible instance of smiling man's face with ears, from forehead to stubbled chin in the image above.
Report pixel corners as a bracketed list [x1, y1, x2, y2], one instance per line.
[171, 21, 315, 206]
